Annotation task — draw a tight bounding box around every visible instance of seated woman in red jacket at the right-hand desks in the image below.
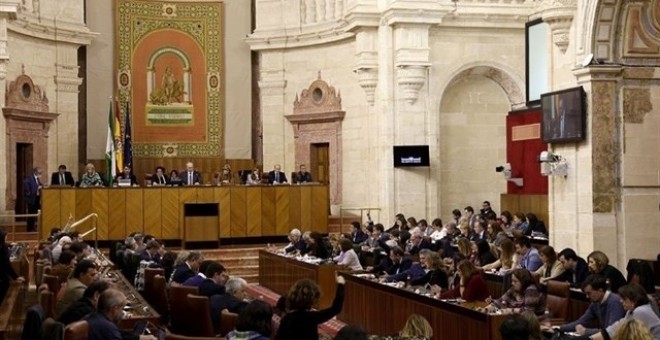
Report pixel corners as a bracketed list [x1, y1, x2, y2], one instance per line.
[434, 260, 490, 301]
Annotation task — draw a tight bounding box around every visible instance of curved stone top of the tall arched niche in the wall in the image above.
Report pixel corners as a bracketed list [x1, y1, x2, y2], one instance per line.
[440, 61, 525, 109]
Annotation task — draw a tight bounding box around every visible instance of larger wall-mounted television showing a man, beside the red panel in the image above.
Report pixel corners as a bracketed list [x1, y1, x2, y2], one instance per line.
[541, 86, 586, 143]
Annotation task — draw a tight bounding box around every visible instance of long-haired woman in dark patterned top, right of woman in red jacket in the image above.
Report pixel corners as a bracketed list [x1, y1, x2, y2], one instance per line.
[486, 268, 545, 316]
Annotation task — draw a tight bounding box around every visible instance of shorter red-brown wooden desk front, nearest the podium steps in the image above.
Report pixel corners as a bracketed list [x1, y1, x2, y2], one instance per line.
[259, 250, 344, 308]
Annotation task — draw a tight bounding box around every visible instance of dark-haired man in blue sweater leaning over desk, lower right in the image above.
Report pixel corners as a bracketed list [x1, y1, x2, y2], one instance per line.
[558, 274, 625, 335]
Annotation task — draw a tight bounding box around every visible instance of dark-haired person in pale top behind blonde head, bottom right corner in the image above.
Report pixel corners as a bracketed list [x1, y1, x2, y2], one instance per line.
[590, 284, 660, 340]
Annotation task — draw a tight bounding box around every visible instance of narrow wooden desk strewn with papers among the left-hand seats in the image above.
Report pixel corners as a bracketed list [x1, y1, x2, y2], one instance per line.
[108, 270, 160, 330]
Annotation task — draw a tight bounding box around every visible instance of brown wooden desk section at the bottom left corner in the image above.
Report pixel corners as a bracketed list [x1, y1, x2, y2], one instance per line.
[0, 281, 27, 340]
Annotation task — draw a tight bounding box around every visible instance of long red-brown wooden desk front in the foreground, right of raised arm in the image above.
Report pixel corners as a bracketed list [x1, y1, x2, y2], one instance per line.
[337, 275, 506, 340]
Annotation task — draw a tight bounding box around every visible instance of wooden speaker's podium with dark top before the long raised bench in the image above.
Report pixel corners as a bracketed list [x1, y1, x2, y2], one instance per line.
[183, 203, 220, 247]
